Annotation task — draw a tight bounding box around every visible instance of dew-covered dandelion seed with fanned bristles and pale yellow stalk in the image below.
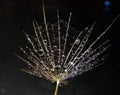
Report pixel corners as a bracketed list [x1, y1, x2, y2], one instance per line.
[17, 0, 119, 95]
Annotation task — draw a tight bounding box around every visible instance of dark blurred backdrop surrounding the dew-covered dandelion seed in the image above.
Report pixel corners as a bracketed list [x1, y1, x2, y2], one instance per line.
[0, 0, 120, 95]
